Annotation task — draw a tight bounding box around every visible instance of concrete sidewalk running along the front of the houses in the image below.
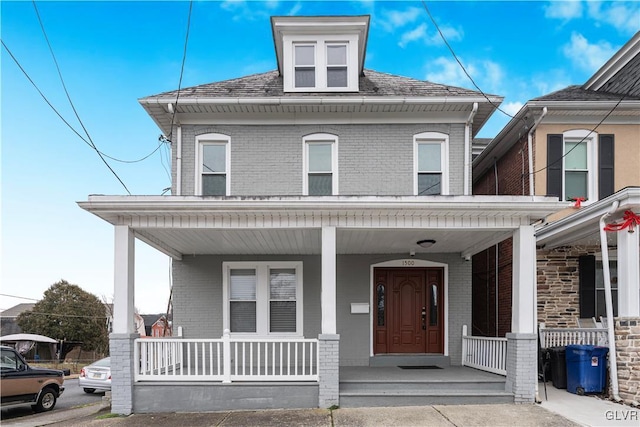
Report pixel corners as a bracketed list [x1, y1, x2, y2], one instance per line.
[2, 383, 640, 427]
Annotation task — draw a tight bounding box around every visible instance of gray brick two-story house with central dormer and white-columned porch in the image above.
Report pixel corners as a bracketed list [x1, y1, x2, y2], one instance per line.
[79, 16, 558, 413]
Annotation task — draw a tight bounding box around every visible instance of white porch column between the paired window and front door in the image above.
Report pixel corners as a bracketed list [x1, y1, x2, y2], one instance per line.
[320, 227, 337, 334]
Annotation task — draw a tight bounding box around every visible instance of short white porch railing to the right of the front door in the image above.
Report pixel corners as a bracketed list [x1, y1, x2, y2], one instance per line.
[462, 325, 507, 375]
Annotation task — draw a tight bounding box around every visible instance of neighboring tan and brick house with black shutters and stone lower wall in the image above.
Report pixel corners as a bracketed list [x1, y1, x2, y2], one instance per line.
[473, 32, 640, 402]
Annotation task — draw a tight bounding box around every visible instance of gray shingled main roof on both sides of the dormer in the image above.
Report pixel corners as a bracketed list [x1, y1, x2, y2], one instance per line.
[142, 69, 497, 99]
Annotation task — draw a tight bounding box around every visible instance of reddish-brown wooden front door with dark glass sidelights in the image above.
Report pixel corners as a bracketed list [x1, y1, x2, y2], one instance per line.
[373, 268, 444, 354]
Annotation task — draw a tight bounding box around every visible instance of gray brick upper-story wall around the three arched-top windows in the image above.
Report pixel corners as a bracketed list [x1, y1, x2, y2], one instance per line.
[172, 124, 470, 196]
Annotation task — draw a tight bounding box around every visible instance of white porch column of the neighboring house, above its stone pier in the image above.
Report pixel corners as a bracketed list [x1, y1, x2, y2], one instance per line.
[617, 230, 640, 317]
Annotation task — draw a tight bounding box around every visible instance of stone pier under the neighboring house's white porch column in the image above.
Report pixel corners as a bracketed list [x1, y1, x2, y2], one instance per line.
[615, 317, 640, 406]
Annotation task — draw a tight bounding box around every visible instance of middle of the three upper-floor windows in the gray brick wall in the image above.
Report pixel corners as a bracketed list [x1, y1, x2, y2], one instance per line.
[302, 134, 338, 196]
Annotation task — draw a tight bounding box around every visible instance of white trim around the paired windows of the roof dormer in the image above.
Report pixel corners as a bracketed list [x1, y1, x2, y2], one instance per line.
[283, 34, 358, 92]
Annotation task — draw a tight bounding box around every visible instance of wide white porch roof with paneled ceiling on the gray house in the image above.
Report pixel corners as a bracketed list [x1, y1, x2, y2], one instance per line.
[78, 196, 568, 259]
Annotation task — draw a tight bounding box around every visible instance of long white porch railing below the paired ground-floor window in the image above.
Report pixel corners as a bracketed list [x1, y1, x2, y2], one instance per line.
[134, 334, 319, 383]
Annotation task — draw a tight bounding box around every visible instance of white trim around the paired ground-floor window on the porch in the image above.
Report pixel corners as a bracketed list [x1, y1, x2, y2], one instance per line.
[222, 261, 304, 338]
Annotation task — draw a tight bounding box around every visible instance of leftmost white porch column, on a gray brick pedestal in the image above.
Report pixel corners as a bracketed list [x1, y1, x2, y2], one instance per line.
[113, 225, 136, 334]
